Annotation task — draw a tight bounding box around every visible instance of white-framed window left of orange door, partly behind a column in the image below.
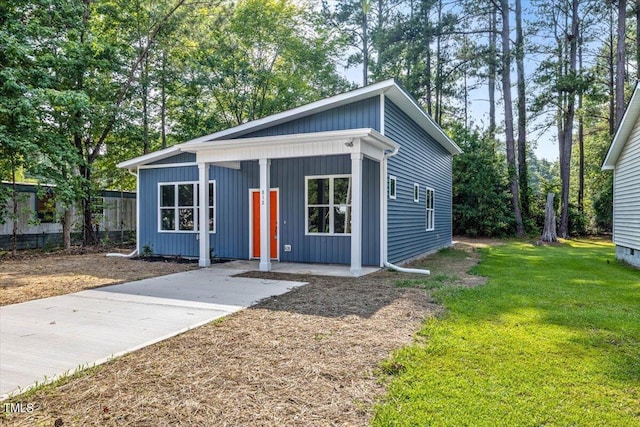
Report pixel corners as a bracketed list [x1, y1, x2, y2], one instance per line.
[158, 181, 216, 233]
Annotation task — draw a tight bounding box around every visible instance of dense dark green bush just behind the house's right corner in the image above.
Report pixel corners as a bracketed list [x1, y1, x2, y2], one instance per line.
[451, 126, 514, 236]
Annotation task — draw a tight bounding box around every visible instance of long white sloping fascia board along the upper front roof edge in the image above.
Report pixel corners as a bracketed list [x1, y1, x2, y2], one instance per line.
[185, 79, 397, 144]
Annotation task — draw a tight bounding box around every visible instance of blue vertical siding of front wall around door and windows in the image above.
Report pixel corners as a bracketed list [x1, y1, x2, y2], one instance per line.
[139, 155, 380, 265]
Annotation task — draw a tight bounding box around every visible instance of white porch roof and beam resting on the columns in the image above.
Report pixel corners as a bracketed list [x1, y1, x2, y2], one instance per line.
[175, 128, 399, 164]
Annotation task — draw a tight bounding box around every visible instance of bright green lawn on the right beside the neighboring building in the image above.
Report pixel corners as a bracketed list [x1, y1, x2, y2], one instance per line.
[373, 241, 640, 427]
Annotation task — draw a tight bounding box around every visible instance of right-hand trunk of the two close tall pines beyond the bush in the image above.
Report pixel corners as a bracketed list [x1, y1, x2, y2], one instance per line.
[516, 0, 529, 218]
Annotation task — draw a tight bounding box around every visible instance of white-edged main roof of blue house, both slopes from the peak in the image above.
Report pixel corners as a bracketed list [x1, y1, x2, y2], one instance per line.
[118, 79, 462, 168]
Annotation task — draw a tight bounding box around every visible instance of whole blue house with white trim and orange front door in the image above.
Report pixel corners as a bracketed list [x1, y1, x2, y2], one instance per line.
[118, 79, 461, 276]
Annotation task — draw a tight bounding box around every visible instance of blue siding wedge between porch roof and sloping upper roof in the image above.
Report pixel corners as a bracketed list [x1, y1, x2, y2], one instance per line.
[242, 96, 380, 138]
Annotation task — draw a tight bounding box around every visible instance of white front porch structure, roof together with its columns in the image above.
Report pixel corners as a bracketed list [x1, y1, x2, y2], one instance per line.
[176, 128, 398, 276]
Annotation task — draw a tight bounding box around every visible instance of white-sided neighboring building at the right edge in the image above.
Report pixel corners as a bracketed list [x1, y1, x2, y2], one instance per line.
[602, 84, 640, 267]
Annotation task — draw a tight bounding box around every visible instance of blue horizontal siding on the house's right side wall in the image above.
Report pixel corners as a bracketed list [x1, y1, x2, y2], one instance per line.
[384, 99, 452, 262]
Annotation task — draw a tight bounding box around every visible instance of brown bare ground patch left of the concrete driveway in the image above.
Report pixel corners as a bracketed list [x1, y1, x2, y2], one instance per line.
[0, 252, 198, 305]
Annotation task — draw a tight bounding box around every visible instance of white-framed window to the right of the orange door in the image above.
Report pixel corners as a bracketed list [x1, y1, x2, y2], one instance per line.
[305, 175, 351, 235]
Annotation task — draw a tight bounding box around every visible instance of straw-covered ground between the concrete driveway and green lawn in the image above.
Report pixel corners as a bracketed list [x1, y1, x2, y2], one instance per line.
[0, 245, 483, 426]
